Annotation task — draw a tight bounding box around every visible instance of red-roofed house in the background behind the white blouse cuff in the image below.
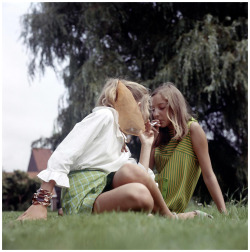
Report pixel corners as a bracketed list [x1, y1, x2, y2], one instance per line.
[27, 148, 58, 211]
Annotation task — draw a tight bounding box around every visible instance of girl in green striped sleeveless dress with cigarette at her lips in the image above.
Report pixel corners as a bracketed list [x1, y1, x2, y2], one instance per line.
[149, 82, 226, 213]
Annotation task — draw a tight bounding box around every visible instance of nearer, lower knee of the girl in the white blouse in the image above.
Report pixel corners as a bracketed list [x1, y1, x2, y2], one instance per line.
[130, 183, 154, 212]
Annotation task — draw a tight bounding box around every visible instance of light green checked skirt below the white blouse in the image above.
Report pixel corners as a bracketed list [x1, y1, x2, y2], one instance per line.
[61, 170, 108, 214]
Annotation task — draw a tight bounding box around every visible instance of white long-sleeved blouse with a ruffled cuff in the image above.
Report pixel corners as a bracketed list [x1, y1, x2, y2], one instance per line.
[37, 106, 152, 187]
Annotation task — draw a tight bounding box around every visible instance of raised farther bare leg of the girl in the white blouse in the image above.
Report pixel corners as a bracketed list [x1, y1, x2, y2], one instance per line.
[113, 164, 173, 217]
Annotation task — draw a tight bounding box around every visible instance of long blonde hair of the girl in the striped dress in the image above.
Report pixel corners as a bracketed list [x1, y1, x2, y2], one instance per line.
[152, 82, 192, 146]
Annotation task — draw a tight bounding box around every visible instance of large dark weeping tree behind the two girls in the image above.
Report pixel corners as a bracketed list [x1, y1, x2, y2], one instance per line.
[22, 2, 248, 200]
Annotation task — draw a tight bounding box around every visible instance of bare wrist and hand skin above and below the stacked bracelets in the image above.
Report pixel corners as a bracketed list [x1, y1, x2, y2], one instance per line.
[17, 180, 55, 221]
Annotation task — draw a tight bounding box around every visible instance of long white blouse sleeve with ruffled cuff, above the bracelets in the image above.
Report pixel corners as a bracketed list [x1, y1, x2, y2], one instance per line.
[37, 109, 114, 187]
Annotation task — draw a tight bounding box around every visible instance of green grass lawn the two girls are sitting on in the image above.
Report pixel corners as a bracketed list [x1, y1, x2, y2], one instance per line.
[2, 204, 248, 250]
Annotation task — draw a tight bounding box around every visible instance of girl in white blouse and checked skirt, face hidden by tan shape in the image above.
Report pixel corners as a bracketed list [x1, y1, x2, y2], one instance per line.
[18, 79, 196, 220]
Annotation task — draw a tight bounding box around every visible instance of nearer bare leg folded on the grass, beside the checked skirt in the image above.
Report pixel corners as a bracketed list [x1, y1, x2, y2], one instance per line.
[93, 183, 154, 213]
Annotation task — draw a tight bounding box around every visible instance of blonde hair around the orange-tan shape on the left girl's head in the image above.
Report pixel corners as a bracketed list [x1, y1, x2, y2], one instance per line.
[96, 78, 150, 122]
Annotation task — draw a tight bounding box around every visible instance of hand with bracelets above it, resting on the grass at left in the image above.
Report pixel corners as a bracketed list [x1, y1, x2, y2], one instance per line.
[17, 205, 47, 221]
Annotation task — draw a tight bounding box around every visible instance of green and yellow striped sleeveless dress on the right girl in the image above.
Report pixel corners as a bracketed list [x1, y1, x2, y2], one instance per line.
[155, 118, 201, 213]
